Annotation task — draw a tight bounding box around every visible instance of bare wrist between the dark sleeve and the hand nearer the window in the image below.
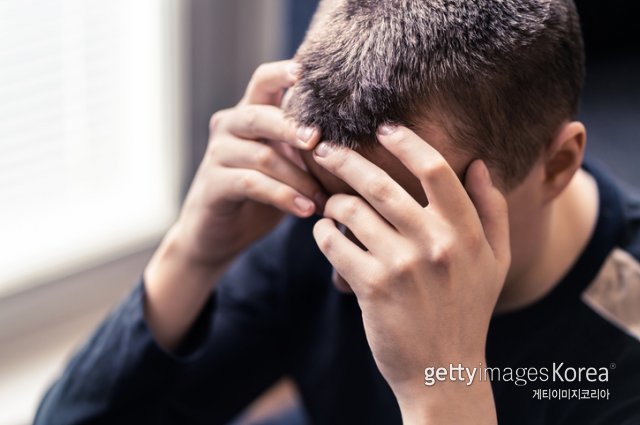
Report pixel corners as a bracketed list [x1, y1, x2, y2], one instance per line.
[144, 226, 225, 351]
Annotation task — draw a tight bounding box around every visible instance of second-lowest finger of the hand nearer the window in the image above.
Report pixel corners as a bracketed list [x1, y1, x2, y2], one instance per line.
[212, 139, 326, 210]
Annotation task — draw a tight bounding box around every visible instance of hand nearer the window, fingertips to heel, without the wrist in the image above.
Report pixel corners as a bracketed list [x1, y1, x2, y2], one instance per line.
[172, 61, 326, 266]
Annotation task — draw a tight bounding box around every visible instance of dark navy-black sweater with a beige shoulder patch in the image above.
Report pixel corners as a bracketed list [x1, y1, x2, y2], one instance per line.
[35, 161, 640, 425]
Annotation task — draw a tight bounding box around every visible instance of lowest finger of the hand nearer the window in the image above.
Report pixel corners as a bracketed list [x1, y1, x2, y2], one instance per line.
[229, 169, 315, 217]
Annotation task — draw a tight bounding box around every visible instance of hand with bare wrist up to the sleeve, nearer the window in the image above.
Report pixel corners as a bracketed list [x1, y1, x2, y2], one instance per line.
[144, 61, 325, 350]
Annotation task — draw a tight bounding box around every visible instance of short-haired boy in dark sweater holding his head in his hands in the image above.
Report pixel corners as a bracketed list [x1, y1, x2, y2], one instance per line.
[36, 0, 640, 425]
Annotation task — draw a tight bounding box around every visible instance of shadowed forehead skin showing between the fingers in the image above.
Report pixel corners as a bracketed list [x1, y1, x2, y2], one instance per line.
[300, 129, 473, 205]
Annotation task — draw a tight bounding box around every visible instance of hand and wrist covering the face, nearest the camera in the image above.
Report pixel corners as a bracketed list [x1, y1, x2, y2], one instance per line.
[314, 126, 510, 424]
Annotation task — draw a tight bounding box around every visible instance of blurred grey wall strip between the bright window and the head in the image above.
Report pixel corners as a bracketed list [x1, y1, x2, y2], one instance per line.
[183, 0, 293, 195]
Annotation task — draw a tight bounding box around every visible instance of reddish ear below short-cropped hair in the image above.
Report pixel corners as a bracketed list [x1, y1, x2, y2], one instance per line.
[544, 121, 587, 203]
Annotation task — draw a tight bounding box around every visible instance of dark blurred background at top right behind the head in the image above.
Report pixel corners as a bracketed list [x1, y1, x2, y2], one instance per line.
[576, 0, 640, 188]
